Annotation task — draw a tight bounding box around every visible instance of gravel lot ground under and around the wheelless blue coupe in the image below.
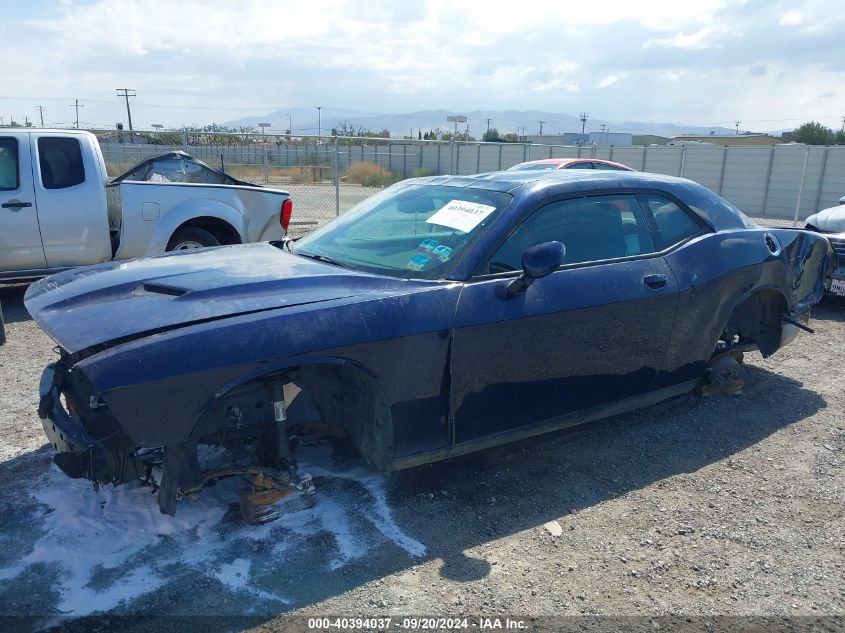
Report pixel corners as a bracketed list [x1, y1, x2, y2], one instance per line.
[0, 287, 845, 631]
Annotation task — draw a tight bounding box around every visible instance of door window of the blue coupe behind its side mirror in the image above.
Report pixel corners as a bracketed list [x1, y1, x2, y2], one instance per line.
[489, 195, 655, 273]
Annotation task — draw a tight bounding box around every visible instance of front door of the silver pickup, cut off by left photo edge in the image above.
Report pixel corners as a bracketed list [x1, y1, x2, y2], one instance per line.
[0, 131, 47, 273]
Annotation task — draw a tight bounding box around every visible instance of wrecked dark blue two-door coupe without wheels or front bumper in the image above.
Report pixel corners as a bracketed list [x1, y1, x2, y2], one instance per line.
[26, 171, 836, 520]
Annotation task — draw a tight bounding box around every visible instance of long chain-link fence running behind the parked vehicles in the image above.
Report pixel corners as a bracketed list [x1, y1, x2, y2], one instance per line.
[95, 131, 845, 234]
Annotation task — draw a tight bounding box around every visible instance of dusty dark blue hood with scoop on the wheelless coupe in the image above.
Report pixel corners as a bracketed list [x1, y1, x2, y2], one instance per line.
[25, 243, 408, 353]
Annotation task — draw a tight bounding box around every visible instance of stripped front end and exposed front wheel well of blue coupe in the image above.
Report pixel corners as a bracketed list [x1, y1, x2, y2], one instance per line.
[38, 349, 316, 523]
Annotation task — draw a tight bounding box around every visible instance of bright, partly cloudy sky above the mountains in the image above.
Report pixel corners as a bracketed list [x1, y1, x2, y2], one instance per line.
[0, 0, 845, 131]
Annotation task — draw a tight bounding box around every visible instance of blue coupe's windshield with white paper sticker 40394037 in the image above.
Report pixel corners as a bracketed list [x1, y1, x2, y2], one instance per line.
[293, 182, 511, 279]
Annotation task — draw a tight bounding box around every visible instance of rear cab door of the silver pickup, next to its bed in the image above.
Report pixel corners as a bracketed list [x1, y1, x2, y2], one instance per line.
[30, 132, 111, 268]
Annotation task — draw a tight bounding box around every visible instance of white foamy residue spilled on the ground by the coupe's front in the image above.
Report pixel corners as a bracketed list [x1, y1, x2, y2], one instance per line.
[0, 448, 426, 616]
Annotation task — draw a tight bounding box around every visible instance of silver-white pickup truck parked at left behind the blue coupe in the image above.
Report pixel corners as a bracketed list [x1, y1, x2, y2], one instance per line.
[0, 128, 292, 282]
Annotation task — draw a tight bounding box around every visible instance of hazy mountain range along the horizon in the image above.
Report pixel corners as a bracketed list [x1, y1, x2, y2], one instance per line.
[226, 108, 743, 138]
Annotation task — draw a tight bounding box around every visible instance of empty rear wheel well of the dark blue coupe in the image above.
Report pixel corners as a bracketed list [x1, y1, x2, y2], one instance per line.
[720, 288, 788, 358]
